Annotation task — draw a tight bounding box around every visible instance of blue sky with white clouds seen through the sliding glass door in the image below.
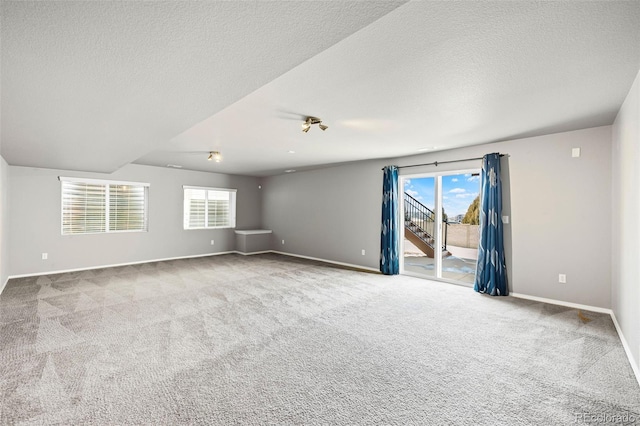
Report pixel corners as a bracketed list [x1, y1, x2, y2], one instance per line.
[404, 173, 480, 216]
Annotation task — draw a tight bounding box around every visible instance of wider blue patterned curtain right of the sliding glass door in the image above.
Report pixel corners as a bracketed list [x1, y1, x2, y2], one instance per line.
[473, 153, 509, 296]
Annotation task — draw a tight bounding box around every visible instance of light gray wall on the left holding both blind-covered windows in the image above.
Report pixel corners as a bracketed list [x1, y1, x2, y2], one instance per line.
[8, 164, 262, 276]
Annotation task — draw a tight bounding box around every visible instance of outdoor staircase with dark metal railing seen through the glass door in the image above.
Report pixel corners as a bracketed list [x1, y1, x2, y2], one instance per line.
[404, 192, 449, 257]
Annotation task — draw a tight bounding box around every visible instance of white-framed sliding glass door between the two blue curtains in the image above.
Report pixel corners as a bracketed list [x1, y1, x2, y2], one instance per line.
[400, 170, 480, 285]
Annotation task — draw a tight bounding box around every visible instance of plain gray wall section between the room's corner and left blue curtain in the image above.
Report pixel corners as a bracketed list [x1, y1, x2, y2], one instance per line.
[262, 161, 384, 269]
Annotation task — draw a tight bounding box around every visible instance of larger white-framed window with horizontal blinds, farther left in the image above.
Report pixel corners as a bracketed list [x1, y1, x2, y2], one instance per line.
[59, 177, 149, 235]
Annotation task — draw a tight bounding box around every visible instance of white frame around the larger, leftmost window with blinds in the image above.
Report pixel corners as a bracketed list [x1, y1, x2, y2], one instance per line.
[58, 176, 151, 237]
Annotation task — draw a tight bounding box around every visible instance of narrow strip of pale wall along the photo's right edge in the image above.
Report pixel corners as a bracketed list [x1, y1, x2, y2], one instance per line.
[611, 69, 640, 368]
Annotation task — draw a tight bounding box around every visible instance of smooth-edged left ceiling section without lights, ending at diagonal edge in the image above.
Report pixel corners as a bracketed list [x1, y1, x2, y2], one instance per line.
[0, 1, 404, 172]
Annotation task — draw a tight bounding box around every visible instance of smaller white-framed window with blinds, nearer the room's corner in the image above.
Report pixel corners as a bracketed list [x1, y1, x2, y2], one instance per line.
[183, 186, 236, 229]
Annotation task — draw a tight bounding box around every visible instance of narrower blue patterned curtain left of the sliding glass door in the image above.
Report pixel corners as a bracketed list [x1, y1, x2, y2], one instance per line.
[380, 166, 400, 275]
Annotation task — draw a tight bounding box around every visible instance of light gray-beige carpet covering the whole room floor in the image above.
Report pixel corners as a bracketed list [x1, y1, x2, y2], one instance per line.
[0, 254, 640, 426]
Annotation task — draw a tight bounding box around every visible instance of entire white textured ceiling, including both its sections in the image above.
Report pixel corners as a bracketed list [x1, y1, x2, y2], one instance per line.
[1, 1, 640, 176]
